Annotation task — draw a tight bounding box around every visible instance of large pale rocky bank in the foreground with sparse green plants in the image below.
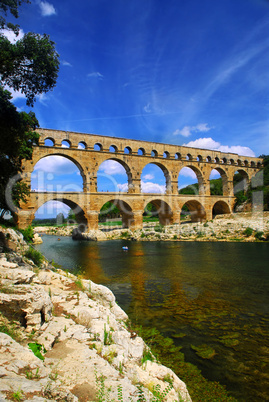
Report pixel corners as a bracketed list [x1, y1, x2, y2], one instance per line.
[0, 227, 191, 402]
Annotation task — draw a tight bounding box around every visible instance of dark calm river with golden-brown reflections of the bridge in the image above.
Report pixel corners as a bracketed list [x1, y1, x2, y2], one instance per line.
[36, 235, 269, 402]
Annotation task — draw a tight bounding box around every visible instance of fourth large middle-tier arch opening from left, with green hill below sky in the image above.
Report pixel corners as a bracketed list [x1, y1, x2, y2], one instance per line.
[178, 166, 205, 195]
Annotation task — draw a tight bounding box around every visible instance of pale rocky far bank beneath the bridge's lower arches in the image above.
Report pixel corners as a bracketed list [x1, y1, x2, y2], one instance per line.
[34, 212, 269, 242]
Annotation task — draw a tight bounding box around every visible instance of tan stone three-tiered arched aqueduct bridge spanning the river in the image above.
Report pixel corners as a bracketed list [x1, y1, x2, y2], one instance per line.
[17, 129, 262, 229]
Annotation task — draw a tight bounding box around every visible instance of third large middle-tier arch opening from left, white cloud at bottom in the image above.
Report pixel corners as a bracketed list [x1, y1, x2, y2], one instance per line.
[141, 163, 171, 194]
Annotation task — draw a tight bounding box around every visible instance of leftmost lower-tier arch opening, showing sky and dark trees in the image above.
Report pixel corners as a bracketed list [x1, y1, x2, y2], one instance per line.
[33, 197, 87, 232]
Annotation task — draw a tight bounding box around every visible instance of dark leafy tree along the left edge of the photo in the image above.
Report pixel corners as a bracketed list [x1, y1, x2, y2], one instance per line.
[0, 0, 59, 218]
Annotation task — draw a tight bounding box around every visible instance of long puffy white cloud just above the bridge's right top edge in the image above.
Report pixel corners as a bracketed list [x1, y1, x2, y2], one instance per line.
[183, 137, 255, 157]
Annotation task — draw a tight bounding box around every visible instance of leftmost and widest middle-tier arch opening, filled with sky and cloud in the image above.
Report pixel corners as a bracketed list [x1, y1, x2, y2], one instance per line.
[31, 155, 85, 192]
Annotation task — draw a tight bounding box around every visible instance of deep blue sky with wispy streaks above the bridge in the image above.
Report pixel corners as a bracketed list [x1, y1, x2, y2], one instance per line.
[2, 0, 269, 218]
